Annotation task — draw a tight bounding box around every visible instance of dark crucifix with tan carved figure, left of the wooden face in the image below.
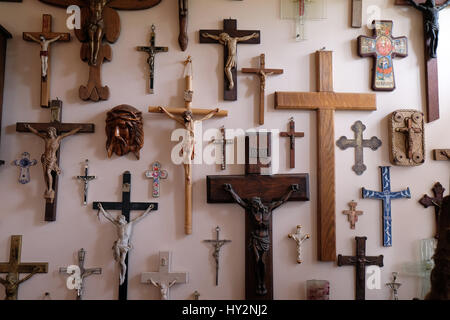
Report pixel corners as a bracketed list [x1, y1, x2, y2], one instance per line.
[16, 100, 95, 221]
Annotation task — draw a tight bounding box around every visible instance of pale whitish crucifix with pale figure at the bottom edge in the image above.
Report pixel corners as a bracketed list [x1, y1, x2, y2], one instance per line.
[141, 251, 188, 300]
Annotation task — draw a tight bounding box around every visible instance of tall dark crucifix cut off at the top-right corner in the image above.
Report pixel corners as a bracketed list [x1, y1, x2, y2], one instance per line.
[395, 0, 450, 122]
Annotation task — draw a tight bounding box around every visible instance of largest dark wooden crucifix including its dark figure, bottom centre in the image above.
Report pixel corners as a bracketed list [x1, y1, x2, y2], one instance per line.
[207, 132, 309, 300]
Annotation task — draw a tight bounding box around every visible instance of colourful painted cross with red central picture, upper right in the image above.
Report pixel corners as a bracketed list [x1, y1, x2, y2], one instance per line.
[358, 20, 408, 91]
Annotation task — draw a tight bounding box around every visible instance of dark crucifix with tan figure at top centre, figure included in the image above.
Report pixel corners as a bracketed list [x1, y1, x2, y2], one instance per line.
[200, 19, 261, 101]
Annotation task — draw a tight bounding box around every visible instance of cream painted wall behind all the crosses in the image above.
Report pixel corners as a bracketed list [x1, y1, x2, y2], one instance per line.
[0, 0, 450, 299]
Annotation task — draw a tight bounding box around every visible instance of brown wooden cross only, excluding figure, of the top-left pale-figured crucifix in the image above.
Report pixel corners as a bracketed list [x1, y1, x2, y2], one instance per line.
[23, 14, 70, 108]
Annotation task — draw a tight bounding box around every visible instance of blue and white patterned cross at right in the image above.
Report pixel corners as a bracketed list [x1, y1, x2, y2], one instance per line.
[362, 166, 411, 247]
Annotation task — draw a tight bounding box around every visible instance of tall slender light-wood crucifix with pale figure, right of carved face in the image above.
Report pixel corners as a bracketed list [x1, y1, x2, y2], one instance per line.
[148, 56, 228, 234]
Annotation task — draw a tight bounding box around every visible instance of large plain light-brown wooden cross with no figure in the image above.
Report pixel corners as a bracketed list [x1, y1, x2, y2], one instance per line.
[275, 51, 377, 261]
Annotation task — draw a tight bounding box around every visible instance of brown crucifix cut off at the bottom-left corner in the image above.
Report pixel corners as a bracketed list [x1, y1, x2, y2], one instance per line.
[0, 235, 48, 300]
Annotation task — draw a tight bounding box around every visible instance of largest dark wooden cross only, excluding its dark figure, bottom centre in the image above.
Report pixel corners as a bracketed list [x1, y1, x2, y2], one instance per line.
[206, 132, 309, 300]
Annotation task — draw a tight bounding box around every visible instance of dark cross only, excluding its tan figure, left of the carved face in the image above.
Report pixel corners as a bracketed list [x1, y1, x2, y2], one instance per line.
[16, 100, 95, 221]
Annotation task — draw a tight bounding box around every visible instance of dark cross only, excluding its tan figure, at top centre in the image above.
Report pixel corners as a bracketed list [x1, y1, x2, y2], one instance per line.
[200, 19, 261, 101]
